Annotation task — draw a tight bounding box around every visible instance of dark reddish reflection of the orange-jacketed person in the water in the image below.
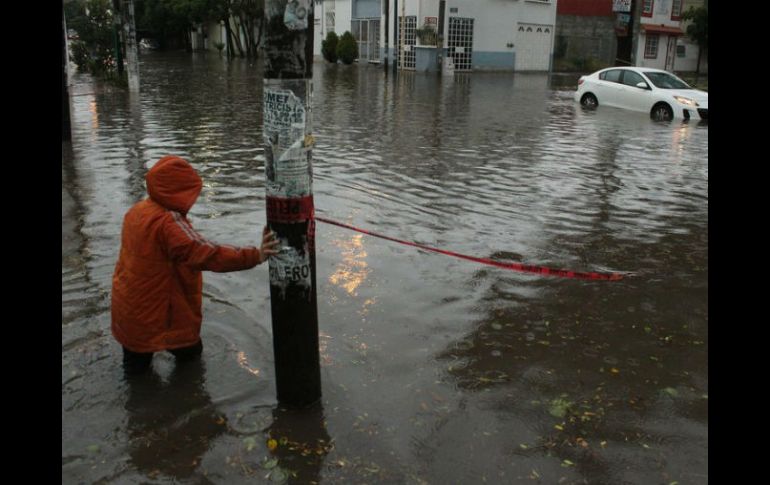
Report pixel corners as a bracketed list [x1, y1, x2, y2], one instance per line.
[125, 359, 227, 479]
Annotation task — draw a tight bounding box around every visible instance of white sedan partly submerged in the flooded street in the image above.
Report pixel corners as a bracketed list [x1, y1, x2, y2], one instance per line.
[575, 67, 709, 121]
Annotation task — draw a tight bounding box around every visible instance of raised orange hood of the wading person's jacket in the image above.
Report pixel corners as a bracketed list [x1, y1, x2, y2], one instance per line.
[145, 155, 203, 214]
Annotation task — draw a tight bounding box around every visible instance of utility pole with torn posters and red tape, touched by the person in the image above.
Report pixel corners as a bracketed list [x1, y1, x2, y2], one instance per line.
[262, 0, 321, 407]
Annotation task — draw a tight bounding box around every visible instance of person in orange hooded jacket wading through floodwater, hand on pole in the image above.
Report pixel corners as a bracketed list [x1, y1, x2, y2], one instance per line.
[112, 156, 279, 373]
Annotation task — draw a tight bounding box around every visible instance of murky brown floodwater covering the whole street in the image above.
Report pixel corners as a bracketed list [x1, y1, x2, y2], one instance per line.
[62, 53, 708, 485]
